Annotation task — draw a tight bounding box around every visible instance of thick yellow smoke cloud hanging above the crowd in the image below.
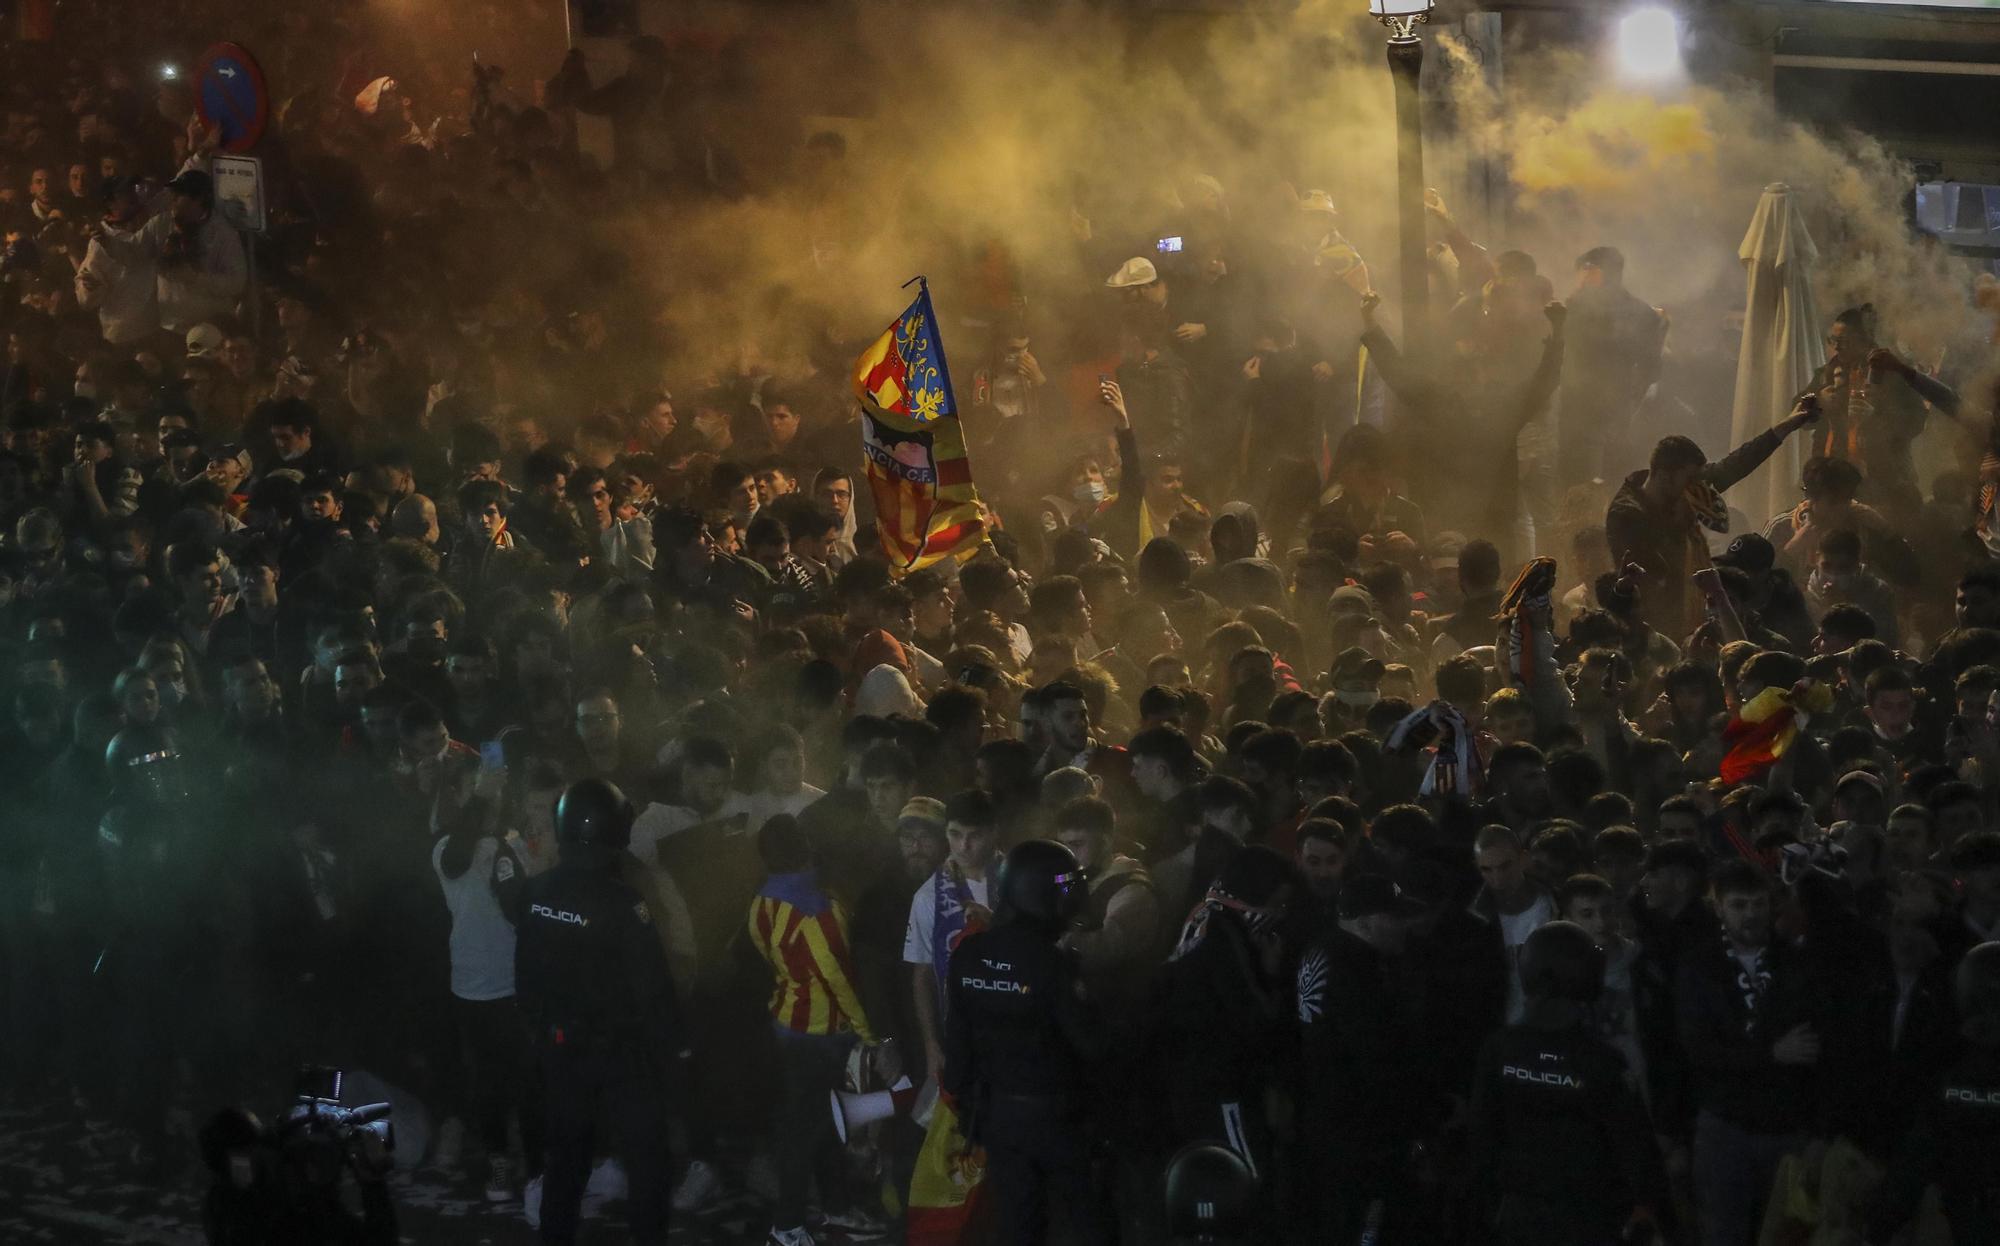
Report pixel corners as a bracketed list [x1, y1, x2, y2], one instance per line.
[352, 0, 1984, 458]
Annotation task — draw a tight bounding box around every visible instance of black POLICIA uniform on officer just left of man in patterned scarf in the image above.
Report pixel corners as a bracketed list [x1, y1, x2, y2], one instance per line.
[1470, 1022, 1666, 1246]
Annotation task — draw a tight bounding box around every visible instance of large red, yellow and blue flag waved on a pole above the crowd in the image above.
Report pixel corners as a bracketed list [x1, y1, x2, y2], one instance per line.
[854, 278, 986, 576]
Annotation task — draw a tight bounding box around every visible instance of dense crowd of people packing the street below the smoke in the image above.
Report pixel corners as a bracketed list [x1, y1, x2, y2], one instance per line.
[11, 2, 2000, 1246]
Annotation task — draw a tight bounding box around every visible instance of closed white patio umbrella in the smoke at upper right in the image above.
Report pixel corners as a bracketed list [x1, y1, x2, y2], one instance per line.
[1728, 182, 1826, 530]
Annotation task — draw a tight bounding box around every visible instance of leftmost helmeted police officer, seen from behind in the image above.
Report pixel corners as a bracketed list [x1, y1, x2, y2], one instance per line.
[514, 778, 684, 1246]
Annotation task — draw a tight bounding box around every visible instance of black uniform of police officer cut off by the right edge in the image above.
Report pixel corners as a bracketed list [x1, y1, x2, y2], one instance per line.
[1868, 1048, 2000, 1242]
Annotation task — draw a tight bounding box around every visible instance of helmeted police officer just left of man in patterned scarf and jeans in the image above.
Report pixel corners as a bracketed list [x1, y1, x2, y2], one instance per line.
[1470, 922, 1666, 1246]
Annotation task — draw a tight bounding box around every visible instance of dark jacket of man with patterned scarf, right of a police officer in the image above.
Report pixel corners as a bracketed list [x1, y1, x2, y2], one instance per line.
[1674, 938, 1818, 1134]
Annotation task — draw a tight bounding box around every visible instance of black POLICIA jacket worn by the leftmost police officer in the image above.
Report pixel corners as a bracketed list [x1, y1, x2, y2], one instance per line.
[514, 848, 684, 1066]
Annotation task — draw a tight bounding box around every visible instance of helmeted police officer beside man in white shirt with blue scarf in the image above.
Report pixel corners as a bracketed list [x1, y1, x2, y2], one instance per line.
[942, 840, 1110, 1246]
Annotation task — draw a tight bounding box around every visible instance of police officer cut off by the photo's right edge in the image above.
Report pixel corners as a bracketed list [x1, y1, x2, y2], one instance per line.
[1868, 942, 2000, 1242]
